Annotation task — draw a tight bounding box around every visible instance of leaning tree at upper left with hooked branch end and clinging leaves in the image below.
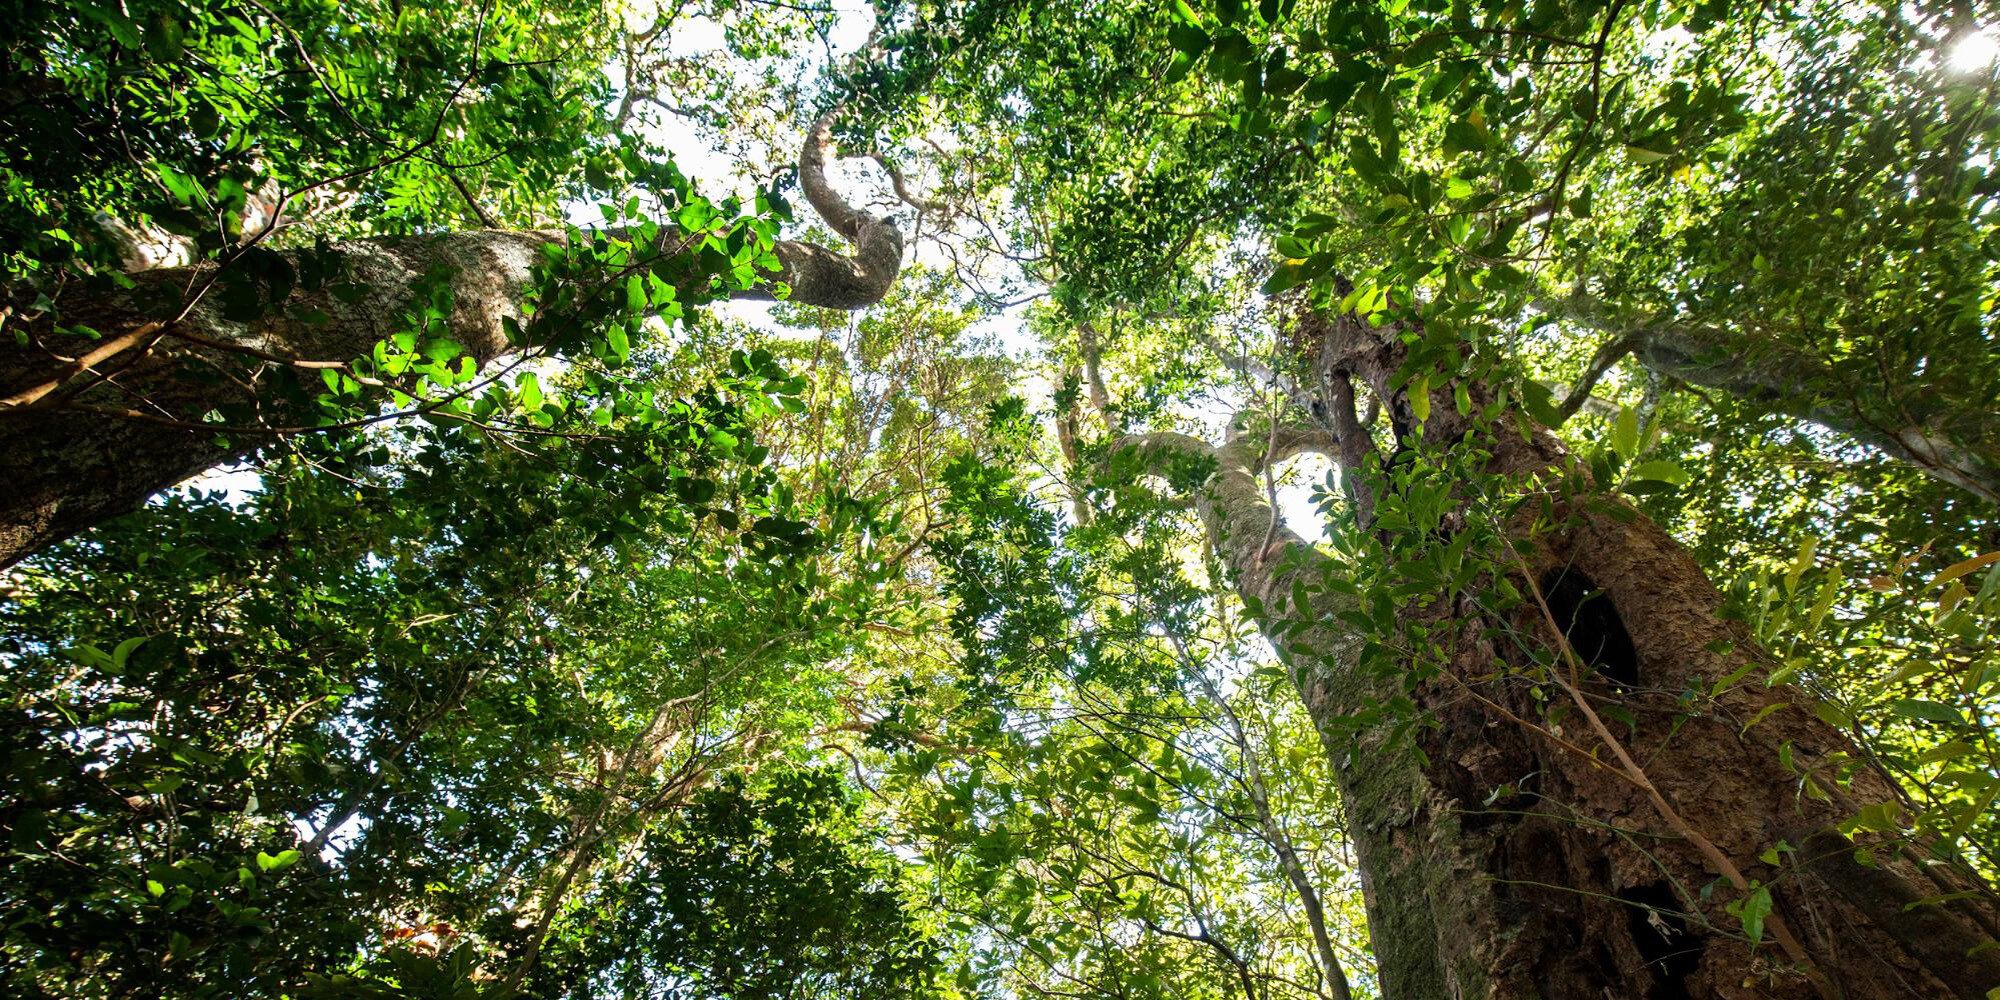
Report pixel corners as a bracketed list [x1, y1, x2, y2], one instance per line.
[0, 0, 902, 566]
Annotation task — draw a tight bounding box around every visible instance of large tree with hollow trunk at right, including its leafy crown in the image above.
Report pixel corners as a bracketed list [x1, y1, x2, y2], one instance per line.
[860, 4, 2000, 996]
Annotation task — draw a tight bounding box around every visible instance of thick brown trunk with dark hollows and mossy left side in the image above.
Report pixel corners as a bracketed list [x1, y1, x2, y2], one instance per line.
[1138, 312, 2000, 1000]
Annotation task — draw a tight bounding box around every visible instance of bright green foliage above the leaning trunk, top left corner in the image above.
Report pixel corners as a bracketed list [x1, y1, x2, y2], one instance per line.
[0, 0, 618, 276]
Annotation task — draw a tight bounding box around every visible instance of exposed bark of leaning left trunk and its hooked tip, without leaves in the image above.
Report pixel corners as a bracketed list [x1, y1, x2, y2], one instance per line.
[0, 116, 902, 568]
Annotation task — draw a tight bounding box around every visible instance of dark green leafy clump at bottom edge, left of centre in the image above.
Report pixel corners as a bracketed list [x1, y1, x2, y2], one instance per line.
[536, 770, 940, 1000]
